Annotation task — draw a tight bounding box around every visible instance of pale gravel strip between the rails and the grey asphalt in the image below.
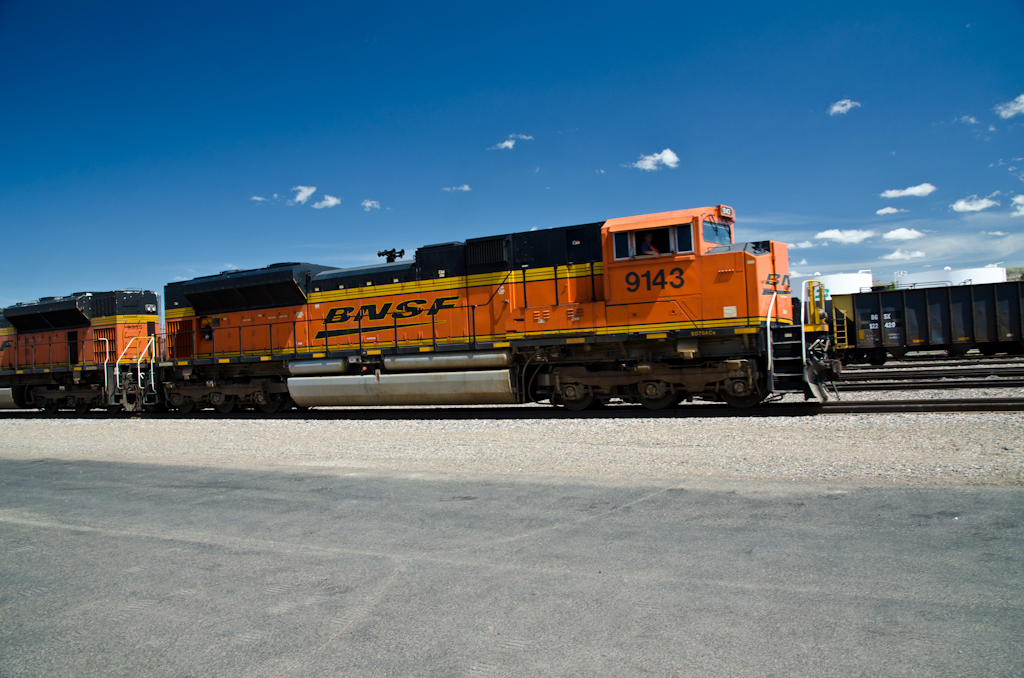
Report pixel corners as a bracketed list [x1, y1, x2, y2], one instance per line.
[0, 413, 1024, 484]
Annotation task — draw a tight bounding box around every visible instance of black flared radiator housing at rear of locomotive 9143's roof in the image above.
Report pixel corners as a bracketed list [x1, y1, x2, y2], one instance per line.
[164, 262, 329, 313]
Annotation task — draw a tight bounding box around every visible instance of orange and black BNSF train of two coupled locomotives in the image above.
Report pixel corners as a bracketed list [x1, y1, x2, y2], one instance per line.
[0, 205, 835, 414]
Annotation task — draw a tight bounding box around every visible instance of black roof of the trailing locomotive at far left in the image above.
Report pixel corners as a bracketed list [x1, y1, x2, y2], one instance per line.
[3, 290, 157, 332]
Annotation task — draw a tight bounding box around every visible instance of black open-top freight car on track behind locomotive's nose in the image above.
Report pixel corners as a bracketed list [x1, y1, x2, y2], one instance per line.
[831, 282, 1024, 365]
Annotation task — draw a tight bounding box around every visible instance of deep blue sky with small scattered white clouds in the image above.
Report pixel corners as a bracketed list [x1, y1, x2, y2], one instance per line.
[0, 0, 1024, 305]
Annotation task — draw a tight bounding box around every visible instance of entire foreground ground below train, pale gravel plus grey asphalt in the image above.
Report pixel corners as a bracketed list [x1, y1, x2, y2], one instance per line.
[0, 403, 1024, 678]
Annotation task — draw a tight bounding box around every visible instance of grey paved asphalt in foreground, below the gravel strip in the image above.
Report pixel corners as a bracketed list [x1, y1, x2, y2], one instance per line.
[0, 461, 1024, 678]
